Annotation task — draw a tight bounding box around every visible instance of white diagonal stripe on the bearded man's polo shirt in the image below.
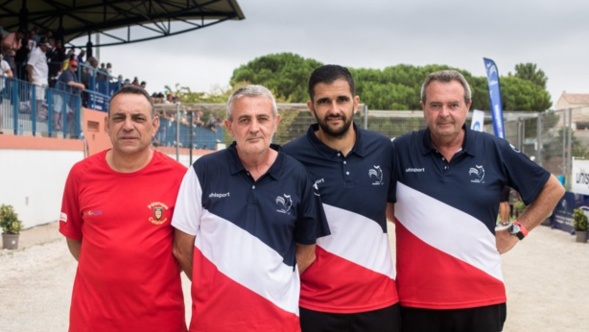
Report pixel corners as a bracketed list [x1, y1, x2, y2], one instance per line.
[317, 203, 395, 279]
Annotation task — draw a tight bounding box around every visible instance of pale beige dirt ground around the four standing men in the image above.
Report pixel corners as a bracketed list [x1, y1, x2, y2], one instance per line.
[0, 223, 589, 332]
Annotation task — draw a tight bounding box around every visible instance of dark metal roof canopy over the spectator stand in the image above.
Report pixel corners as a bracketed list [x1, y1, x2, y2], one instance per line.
[0, 0, 245, 47]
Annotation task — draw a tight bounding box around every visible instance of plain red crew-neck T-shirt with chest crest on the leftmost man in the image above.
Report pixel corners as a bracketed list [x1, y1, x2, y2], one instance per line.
[59, 151, 186, 332]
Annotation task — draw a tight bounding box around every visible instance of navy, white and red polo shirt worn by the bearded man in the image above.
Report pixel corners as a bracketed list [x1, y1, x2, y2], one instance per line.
[284, 125, 398, 313]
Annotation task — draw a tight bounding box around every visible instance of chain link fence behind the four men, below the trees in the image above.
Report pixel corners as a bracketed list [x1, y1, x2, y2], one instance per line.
[156, 104, 589, 188]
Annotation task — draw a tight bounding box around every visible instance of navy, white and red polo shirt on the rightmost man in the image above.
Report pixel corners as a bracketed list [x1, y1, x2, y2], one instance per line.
[393, 127, 550, 309]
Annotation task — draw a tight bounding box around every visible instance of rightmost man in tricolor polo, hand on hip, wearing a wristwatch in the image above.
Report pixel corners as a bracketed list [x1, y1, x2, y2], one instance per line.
[390, 70, 564, 332]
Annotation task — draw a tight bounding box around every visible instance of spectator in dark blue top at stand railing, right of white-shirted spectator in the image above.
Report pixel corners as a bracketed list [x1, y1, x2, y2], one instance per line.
[53, 60, 85, 137]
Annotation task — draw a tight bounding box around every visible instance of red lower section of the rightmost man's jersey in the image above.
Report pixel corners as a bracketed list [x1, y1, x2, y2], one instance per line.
[395, 221, 506, 309]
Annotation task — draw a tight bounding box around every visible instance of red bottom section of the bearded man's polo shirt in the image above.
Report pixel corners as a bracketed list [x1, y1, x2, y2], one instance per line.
[300, 246, 399, 313]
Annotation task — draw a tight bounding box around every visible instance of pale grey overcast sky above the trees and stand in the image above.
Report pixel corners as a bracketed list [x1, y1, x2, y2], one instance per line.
[76, 0, 589, 107]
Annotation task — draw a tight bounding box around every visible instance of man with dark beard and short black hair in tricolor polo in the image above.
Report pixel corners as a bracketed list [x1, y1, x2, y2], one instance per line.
[283, 65, 399, 332]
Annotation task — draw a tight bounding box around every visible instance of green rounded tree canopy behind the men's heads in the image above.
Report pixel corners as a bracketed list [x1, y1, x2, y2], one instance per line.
[169, 53, 552, 112]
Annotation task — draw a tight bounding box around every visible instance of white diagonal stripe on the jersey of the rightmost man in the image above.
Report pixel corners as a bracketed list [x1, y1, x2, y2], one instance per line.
[395, 182, 503, 281]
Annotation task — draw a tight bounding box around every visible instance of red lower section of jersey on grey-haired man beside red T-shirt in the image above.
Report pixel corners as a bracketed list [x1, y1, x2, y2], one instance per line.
[190, 247, 300, 332]
